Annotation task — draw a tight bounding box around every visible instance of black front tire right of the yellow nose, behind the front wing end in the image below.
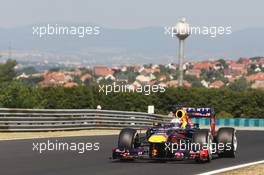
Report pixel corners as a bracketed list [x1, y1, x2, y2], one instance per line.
[192, 129, 213, 163]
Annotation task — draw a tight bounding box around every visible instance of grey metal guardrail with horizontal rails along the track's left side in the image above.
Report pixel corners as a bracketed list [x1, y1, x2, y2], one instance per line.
[0, 108, 169, 131]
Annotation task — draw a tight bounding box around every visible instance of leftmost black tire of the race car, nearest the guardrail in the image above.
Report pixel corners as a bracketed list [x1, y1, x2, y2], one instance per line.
[118, 128, 140, 149]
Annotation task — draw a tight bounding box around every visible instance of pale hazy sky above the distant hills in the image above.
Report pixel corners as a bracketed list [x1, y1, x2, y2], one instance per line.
[0, 0, 264, 29]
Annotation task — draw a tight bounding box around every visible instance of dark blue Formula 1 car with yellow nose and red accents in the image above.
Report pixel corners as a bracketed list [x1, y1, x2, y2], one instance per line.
[112, 106, 237, 162]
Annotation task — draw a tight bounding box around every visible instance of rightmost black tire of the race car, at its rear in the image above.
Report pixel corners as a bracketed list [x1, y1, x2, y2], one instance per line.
[216, 127, 237, 157]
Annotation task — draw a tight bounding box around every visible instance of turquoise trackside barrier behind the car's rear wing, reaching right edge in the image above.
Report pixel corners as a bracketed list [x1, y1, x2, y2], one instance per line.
[193, 118, 264, 127]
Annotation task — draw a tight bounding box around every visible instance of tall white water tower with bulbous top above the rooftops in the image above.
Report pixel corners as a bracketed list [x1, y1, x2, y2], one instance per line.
[173, 18, 190, 86]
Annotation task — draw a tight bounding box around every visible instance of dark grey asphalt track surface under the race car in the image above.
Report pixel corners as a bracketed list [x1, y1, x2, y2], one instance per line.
[0, 131, 264, 175]
